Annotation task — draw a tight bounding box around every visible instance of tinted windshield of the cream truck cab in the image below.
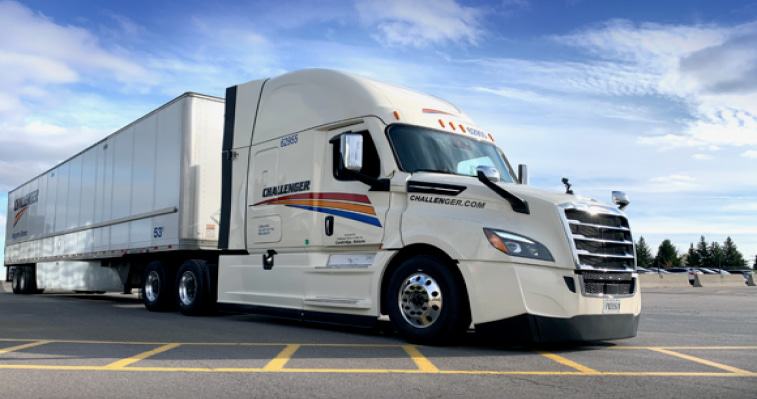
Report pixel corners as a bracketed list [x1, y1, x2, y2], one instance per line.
[387, 125, 514, 183]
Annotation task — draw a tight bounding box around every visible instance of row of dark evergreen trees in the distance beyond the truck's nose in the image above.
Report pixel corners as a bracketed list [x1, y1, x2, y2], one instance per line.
[636, 236, 757, 270]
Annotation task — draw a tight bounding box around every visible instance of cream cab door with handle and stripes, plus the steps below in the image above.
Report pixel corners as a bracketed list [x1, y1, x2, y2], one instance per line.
[304, 122, 393, 318]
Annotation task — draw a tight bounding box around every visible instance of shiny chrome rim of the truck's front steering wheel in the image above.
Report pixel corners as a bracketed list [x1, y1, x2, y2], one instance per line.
[399, 273, 442, 328]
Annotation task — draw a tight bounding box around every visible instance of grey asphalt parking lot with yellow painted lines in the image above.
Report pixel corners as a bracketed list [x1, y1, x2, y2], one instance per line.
[0, 285, 757, 398]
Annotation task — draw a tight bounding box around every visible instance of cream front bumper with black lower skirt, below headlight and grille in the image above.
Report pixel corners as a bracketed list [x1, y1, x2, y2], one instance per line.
[459, 261, 641, 342]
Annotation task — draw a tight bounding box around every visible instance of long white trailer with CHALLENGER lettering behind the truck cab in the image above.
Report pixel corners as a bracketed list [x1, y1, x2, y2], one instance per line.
[5, 93, 224, 298]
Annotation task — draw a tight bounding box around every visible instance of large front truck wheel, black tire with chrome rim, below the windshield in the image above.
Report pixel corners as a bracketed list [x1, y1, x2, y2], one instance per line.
[386, 255, 471, 345]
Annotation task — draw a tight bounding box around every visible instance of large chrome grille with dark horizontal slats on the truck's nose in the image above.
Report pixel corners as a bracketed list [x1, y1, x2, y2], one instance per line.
[561, 203, 636, 271]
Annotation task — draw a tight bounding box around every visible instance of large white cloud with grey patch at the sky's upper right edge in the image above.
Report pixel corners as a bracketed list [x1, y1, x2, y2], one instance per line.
[555, 20, 757, 153]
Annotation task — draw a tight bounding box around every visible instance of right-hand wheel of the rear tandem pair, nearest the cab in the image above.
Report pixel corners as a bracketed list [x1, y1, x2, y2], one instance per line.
[176, 259, 215, 316]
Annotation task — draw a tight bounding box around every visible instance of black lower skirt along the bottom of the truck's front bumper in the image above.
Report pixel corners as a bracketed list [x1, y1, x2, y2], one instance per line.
[476, 314, 639, 343]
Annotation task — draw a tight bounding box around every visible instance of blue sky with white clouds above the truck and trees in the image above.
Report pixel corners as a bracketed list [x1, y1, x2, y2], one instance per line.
[0, 0, 757, 268]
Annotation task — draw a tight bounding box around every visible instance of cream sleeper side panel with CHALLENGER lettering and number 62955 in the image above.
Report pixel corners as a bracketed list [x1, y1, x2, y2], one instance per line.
[239, 132, 320, 314]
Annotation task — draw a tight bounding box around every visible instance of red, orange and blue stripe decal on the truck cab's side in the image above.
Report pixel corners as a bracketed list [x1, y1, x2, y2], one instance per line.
[253, 193, 381, 227]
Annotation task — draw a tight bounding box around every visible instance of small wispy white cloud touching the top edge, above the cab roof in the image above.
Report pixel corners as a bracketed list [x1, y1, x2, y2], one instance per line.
[355, 0, 485, 47]
